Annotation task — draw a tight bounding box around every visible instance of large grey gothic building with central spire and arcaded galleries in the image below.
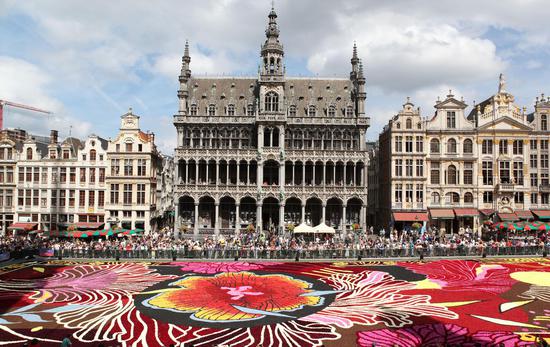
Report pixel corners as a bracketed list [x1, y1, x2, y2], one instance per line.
[174, 9, 369, 235]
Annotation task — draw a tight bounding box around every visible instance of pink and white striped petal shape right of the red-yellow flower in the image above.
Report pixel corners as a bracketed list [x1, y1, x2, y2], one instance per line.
[303, 271, 458, 328]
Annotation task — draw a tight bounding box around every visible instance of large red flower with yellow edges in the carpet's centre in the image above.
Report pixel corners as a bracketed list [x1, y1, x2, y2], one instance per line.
[147, 272, 321, 321]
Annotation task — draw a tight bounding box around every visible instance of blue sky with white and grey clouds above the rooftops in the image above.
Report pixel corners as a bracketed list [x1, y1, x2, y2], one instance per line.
[0, 0, 550, 153]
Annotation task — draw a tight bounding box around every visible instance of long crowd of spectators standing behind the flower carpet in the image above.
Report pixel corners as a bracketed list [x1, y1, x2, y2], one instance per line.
[0, 228, 550, 259]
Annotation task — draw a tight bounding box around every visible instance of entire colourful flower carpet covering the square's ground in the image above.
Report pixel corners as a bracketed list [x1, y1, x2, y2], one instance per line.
[0, 258, 550, 347]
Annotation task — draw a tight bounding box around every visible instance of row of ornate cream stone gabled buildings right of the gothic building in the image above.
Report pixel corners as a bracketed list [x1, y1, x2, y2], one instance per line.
[377, 75, 550, 232]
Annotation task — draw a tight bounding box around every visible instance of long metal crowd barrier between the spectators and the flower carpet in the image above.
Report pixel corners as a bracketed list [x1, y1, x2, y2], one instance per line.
[54, 246, 550, 260]
